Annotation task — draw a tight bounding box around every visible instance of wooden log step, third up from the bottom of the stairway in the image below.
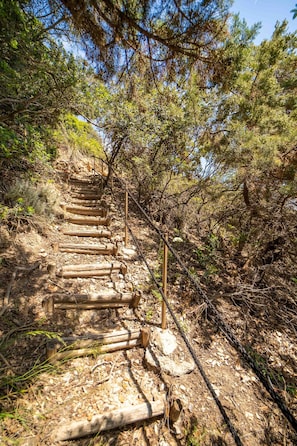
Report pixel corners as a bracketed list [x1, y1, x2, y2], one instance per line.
[44, 289, 141, 314]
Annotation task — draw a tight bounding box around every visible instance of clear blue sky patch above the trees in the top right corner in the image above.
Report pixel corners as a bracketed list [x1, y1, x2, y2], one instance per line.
[232, 0, 297, 44]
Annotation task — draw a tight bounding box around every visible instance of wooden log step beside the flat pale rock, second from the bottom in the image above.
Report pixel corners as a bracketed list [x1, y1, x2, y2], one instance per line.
[47, 328, 150, 363]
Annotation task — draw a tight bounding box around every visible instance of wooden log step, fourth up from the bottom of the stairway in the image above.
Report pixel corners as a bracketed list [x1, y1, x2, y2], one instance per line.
[57, 262, 127, 278]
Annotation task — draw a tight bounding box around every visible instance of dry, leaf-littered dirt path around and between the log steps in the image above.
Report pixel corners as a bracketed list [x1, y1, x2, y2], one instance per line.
[0, 168, 296, 446]
